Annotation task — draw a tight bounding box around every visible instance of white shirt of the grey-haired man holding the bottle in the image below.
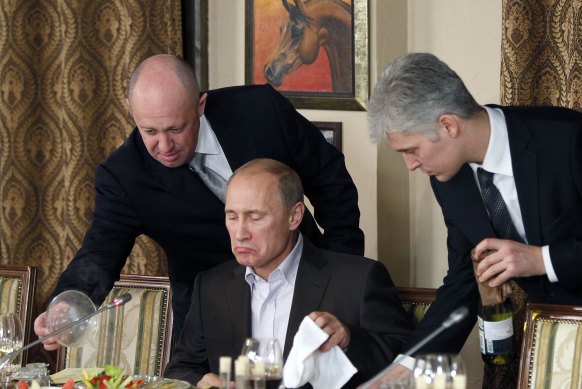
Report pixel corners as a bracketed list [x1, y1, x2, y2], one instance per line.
[469, 107, 558, 282]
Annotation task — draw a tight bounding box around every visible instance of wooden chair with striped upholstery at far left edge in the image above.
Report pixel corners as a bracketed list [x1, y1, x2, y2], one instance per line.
[0, 265, 36, 364]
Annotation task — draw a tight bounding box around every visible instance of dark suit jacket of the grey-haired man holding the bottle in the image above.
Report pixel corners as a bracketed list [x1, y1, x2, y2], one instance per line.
[407, 106, 582, 352]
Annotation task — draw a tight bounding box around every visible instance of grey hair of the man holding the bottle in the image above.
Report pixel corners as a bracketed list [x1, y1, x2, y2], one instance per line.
[368, 53, 483, 143]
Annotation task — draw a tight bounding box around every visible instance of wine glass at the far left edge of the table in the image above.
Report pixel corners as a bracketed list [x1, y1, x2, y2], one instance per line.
[0, 313, 24, 388]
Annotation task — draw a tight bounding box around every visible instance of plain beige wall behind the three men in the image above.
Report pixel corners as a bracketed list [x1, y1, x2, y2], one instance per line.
[209, 0, 501, 287]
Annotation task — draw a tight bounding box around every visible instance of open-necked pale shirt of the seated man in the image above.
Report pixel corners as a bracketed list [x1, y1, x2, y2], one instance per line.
[245, 234, 303, 350]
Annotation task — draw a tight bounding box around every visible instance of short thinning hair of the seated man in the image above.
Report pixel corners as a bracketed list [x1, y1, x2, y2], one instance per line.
[228, 158, 303, 211]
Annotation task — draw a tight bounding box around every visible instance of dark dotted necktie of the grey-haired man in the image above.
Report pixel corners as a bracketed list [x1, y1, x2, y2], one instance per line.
[477, 168, 523, 242]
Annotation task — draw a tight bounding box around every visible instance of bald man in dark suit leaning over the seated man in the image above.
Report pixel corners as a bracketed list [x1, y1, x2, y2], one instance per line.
[35, 55, 364, 349]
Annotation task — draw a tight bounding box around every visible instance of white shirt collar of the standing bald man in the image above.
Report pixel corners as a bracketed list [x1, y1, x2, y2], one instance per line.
[189, 115, 232, 181]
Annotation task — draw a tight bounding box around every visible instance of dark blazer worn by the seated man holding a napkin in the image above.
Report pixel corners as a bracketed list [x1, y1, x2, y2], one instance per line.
[164, 239, 412, 387]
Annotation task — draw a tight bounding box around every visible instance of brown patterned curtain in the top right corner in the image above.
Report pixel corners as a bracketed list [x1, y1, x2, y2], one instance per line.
[501, 0, 582, 110]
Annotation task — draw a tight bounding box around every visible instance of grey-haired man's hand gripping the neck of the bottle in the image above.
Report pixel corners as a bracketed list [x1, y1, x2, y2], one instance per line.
[474, 238, 546, 287]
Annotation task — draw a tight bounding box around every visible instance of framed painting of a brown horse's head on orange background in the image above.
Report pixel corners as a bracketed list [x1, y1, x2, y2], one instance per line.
[245, 0, 369, 110]
